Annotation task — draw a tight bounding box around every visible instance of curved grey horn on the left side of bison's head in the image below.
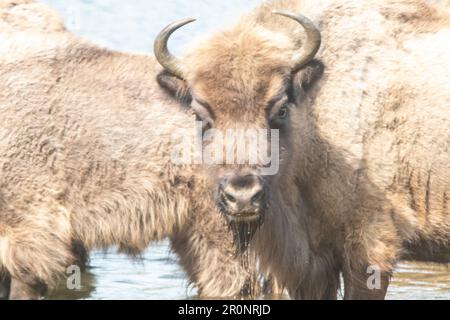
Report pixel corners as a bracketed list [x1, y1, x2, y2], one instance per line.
[153, 18, 196, 79]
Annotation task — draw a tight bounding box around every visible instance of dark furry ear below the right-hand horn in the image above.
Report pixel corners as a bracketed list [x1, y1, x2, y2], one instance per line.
[292, 60, 325, 102]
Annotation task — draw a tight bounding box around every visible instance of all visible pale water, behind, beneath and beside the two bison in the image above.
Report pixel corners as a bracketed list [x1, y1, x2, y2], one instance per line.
[37, 0, 450, 299]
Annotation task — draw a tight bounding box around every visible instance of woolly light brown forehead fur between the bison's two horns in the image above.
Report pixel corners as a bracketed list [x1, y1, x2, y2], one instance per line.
[184, 24, 295, 112]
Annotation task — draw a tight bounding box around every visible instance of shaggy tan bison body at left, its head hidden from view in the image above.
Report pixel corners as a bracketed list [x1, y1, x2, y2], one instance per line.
[0, 0, 257, 298]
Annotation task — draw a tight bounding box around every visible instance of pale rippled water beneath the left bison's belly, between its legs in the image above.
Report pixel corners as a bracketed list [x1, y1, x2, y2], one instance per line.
[49, 242, 193, 300]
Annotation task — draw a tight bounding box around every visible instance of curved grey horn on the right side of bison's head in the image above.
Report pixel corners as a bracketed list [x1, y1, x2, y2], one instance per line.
[273, 11, 322, 72]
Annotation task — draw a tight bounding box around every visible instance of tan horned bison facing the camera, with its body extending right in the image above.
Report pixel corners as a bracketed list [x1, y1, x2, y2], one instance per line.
[155, 0, 450, 299]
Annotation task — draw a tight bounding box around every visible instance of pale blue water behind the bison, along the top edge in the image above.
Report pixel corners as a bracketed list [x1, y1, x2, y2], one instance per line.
[41, 0, 261, 53]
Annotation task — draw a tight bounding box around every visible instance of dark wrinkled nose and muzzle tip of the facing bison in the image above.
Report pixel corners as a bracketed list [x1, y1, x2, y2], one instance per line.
[219, 175, 266, 218]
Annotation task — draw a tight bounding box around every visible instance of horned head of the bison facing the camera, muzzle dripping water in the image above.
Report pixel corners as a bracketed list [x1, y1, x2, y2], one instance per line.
[154, 12, 323, 235]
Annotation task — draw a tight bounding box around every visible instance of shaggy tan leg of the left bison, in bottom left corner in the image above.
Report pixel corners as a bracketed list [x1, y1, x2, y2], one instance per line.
[2, 207, 76, 299]
